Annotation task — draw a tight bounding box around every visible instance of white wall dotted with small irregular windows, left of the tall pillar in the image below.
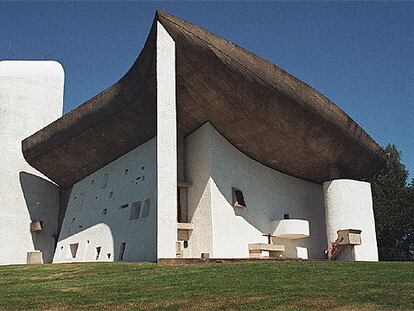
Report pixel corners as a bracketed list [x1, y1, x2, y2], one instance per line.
[53, 138, 156, 262]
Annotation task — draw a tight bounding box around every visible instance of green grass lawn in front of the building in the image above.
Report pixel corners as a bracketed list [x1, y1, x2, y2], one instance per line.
[0, 261, 414, 311]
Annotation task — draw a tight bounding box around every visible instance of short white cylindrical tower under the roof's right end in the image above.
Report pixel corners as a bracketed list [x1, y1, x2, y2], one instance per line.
[323, 179, 378, 261]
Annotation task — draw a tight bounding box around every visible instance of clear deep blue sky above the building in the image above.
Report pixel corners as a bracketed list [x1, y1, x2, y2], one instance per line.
[0, 1, 414, 182]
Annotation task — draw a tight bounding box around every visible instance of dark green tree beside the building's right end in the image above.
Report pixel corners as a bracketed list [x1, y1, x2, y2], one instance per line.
[371, 144, 414, 260]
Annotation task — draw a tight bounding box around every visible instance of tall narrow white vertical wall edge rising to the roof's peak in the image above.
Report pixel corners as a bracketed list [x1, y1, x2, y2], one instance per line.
[156, 22, 177, 258]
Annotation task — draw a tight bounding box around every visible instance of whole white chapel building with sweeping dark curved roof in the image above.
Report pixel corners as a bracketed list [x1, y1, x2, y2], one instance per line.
[0, 12, 385, 264]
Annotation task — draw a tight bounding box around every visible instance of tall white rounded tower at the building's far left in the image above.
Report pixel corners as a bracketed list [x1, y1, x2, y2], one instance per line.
[0, 61, 64, 264]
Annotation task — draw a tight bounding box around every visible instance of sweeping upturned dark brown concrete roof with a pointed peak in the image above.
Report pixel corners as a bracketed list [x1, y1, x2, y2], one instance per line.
[22, 12, 385, 188]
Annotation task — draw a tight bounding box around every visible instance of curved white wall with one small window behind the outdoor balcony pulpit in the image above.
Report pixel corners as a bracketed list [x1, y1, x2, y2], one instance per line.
[186, 123, 326, 259]
